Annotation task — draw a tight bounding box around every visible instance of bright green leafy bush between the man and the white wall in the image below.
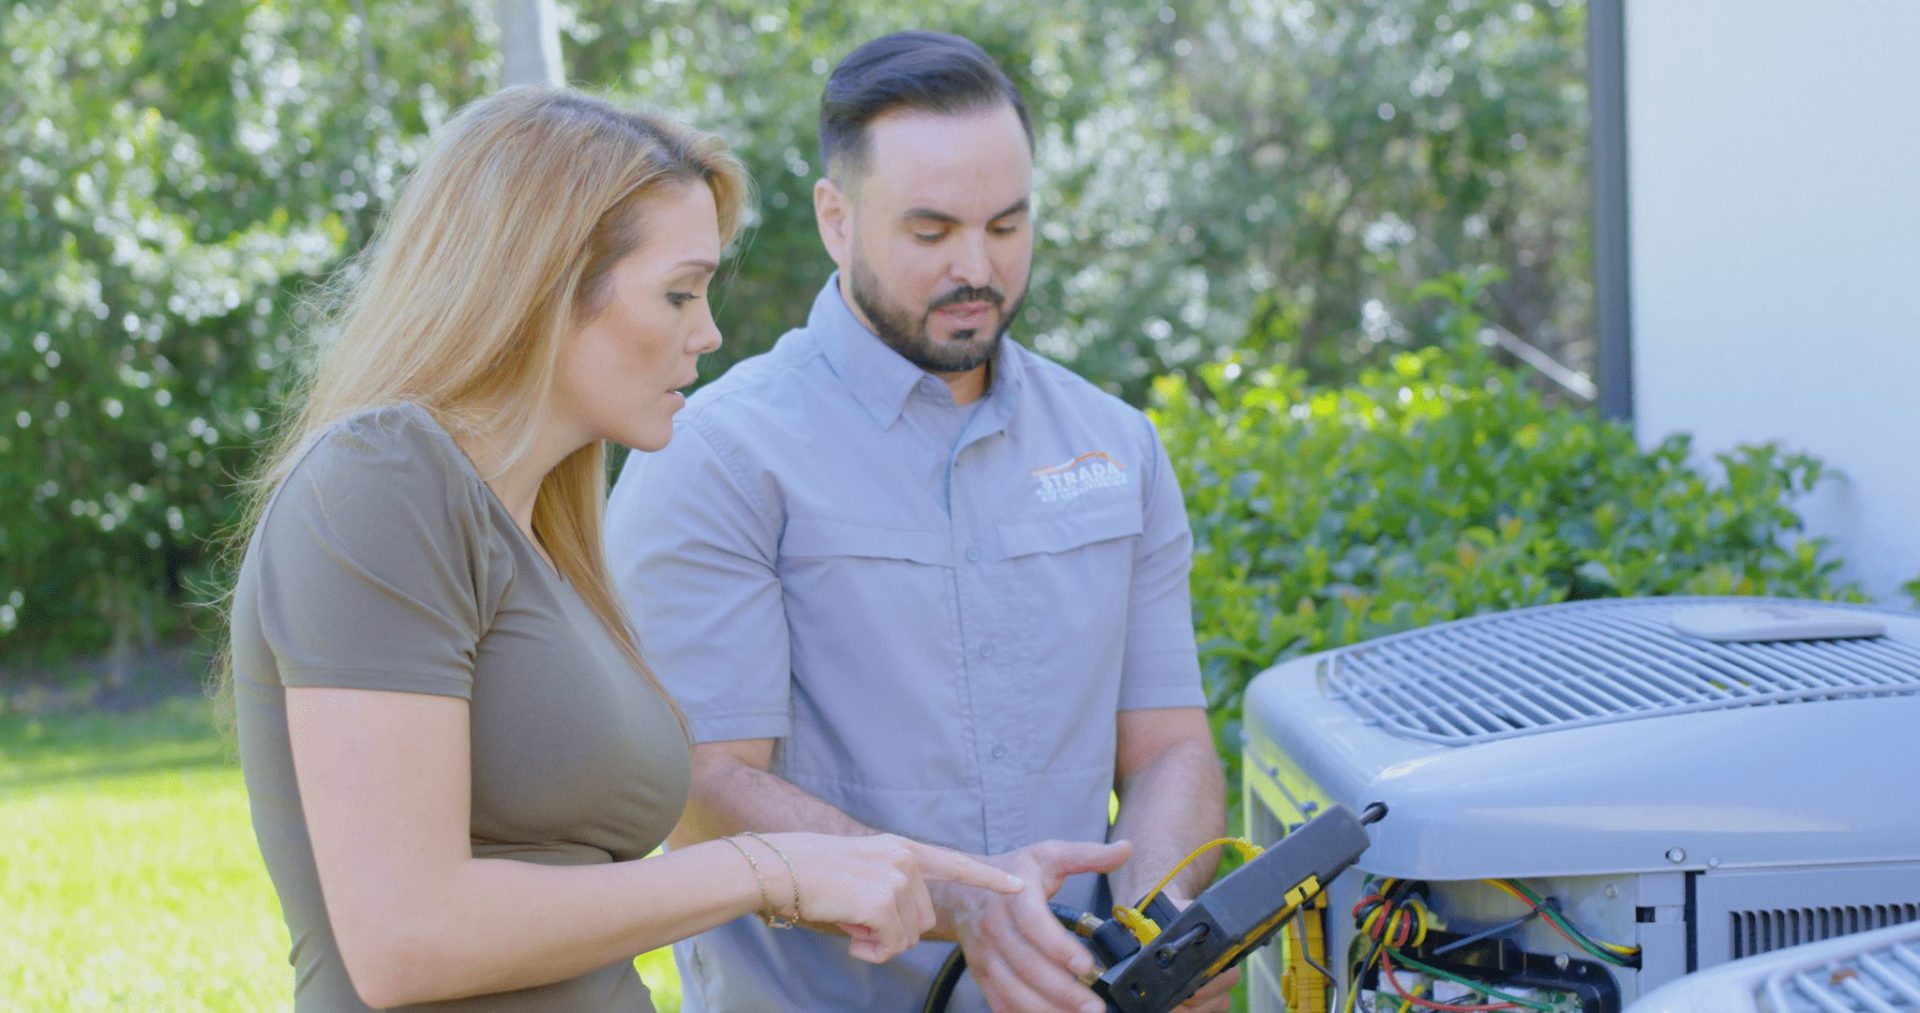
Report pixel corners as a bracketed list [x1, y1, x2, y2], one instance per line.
[1150, 276, 1860, 813]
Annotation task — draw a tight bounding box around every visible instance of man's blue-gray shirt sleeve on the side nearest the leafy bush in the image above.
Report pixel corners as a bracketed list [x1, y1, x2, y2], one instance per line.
[1119, 416, 1206, 710]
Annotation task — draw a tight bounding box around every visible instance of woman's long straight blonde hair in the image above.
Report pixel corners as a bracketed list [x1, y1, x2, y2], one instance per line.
[219, 88, 749, 710]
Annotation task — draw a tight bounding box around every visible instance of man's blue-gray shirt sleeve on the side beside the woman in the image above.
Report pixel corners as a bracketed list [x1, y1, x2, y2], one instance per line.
[607, 414, 793, 742]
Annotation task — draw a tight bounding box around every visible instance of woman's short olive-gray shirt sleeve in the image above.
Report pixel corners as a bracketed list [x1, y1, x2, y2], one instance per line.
[255, 411, 490, 700]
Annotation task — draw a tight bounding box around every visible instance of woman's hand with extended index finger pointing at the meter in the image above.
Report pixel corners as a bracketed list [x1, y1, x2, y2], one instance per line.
[743, 833, 1023, 963]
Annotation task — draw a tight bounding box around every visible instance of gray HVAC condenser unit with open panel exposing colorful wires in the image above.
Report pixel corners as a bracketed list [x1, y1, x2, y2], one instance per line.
[1244, 599, 1920, 1013]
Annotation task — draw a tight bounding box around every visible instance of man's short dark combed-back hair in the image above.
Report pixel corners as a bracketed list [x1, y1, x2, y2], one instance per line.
[820, 31, 1033, 186]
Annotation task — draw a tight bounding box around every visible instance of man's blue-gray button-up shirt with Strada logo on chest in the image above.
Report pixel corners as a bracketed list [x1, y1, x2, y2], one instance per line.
[607, 278, 1204, 1011]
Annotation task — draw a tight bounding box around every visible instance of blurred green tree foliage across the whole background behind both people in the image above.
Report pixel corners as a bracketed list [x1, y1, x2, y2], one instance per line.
[0, 0, 1588, 656]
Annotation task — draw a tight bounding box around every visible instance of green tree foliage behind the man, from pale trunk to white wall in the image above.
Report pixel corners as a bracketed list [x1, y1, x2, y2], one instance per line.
[566, 0, 1592, 399]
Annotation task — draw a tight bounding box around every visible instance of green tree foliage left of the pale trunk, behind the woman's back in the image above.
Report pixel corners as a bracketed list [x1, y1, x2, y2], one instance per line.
[0, 0, 492, 671]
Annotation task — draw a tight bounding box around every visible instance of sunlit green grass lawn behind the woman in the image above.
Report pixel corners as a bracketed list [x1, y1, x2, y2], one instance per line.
[0, 698, 680, 1013]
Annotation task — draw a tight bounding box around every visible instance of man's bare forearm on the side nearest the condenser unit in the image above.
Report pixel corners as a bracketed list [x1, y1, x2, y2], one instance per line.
[1108, 741, 1227, 904]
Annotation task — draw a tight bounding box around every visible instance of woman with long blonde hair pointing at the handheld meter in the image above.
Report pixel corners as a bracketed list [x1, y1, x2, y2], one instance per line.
[230, 90, 1018, 1009]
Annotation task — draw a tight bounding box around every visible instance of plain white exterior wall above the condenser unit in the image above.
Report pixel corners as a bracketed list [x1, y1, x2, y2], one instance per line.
[1626, 0, 1920, 604]
